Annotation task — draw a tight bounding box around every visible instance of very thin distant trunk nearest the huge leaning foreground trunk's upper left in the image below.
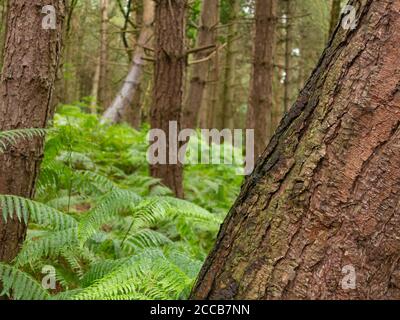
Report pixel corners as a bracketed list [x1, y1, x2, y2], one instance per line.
[283, 0, 293, 111]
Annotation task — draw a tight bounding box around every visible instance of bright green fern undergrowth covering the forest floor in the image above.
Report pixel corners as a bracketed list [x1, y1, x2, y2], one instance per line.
[0, 105, 241, 300]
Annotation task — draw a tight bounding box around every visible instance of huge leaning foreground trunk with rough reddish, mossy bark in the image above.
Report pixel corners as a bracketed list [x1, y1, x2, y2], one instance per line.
[192, 0, 400, 299]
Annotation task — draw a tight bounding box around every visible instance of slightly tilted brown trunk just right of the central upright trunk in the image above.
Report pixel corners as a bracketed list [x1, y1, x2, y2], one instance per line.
[183, 0, 219, 128]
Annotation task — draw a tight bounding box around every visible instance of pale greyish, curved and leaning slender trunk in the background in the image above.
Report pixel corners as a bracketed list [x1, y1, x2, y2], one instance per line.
[103, 0, 154, 123]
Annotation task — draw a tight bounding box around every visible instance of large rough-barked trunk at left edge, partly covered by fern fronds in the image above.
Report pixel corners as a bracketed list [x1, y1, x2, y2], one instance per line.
[0, 0, 65, 261]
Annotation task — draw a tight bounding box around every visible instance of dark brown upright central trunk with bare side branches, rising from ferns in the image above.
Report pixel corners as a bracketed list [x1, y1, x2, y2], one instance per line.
[150, 0, 187, 197]
